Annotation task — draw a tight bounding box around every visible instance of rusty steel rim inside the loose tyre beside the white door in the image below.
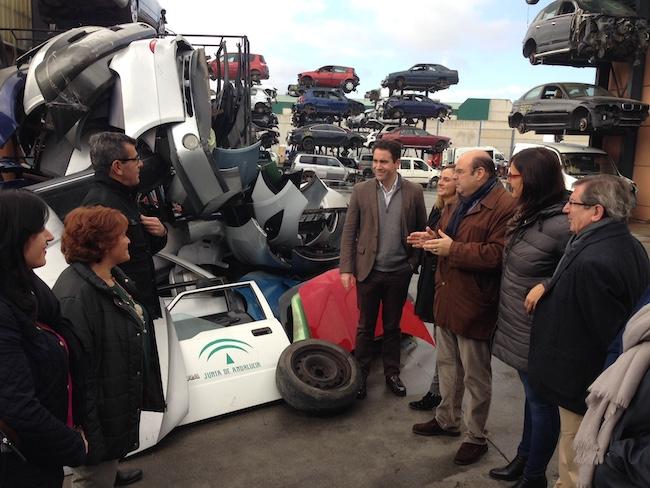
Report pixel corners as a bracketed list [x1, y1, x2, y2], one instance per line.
[291, 345, 352, 390]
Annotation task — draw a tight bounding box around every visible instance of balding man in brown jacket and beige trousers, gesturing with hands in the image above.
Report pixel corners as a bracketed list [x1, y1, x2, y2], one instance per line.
[409, 151, 515, 465]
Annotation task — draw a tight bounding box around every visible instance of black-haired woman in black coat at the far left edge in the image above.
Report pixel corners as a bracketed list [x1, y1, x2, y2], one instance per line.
[0, 190, 86, 488]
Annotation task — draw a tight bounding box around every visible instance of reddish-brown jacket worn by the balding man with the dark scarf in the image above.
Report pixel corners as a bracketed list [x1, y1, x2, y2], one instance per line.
[433, 182, 516, 340]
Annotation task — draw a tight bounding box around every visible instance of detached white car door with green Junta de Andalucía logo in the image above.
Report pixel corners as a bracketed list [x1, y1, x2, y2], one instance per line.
[167, 281, 289, 425]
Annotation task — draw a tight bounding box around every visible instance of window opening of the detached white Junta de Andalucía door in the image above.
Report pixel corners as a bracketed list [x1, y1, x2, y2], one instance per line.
[171, 285, 266, 342]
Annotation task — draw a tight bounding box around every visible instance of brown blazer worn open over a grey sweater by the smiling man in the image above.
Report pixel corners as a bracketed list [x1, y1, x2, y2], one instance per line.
[340, 177, 427, 281]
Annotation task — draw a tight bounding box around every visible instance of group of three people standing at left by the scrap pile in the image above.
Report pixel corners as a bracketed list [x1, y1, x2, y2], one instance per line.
[0, 132, 167, 488]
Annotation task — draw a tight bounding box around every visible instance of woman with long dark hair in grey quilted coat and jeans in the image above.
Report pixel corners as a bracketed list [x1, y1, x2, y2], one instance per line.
[490, 148, 570, 488]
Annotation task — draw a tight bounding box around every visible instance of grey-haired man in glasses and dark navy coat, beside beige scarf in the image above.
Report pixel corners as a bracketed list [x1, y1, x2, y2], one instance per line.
[528, 175, 650, 488]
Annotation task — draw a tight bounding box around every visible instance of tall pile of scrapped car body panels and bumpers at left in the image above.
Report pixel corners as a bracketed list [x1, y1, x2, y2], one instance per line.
[0, 24, 346, 274]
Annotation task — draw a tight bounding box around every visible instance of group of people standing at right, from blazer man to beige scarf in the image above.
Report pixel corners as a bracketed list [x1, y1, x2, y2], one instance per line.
[340, 141, 650, 488]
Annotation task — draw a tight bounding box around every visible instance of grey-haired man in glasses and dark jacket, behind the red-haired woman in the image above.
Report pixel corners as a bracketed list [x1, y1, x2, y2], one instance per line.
[82, 132, 167, 318]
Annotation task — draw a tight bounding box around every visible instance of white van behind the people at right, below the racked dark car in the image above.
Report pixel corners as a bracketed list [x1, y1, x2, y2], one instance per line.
[512, 142, 636, 190]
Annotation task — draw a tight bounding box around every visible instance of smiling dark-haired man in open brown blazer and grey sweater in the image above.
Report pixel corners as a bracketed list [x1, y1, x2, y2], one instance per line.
[340, 140, 426, 399]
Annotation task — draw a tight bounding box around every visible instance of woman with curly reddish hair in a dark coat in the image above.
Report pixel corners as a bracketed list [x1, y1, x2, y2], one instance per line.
[54, 206, 164, 488]
